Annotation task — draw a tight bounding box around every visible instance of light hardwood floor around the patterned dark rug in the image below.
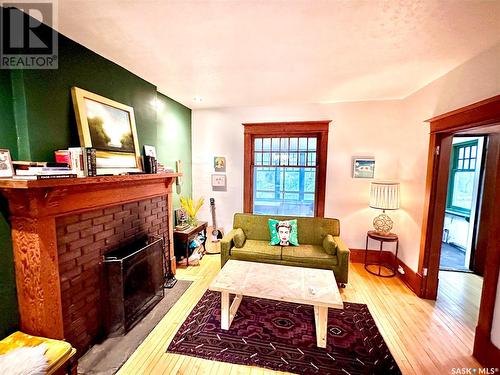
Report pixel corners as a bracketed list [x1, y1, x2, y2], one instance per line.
[119, 250, 482, 375]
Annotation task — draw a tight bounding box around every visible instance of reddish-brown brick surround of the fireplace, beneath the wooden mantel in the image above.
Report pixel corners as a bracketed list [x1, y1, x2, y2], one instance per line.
[56, 196, 168, 351]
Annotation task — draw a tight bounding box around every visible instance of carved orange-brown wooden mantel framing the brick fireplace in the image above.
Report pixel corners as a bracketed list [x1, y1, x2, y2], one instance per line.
[0, 173, 180, 339]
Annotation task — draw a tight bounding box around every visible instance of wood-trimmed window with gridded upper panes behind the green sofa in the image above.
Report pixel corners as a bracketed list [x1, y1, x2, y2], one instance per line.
[244, 121, 329, 216]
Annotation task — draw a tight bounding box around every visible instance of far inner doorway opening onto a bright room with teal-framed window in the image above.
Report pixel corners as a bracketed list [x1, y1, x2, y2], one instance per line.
[439, 135, 486, 275]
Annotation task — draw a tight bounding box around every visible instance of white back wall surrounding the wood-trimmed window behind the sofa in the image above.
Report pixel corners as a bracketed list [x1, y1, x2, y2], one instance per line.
[193, 101, 427, 268]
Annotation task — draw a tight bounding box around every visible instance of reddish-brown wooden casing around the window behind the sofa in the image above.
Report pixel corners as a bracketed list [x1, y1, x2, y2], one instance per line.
[243, 120, 331, 217]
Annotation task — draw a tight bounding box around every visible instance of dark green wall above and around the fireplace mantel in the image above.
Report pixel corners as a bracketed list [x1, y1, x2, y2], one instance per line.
[0, 26, 191, 338]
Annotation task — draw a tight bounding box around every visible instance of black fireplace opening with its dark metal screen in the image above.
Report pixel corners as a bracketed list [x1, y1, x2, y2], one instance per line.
[103, 236, 165, 337]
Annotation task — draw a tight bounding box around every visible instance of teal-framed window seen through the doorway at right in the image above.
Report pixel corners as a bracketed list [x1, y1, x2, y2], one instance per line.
[446, 140, 479, 216]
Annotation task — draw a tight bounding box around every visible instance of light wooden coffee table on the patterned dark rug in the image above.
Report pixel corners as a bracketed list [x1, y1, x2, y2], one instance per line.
[209, 260, 344, 348]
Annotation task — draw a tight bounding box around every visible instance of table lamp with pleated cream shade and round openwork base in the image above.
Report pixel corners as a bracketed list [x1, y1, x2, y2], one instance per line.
[370, 181, 399, 235]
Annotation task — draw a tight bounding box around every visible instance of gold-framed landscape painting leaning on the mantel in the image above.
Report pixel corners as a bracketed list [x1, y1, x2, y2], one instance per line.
[71, 87, 142, 175]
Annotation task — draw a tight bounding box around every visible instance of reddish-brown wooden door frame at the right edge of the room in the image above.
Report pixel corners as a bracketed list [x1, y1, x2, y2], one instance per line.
[418, 95, 500, 367]
